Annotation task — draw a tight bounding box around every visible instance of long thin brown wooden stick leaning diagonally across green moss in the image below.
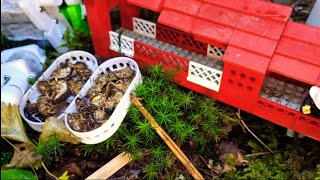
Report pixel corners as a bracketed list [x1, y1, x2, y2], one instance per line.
[131, 95, 204, 180]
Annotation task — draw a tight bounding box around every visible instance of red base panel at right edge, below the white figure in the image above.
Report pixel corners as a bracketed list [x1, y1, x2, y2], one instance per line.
[292, 113, 320, 141]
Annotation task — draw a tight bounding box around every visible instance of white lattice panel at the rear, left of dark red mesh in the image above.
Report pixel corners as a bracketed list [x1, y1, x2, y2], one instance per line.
[133, 17, 156, 39]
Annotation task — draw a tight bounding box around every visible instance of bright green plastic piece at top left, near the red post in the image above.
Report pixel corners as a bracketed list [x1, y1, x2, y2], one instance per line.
[60, 3, 90, 35]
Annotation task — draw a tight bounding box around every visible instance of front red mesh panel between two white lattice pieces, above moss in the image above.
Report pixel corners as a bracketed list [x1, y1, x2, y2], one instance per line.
[134, 41, 189, 72]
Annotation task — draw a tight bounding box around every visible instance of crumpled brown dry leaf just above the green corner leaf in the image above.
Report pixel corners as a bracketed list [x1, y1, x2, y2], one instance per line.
[1, 143, 41, 169]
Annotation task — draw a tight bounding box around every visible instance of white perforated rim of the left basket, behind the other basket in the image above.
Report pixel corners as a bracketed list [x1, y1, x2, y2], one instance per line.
[19, 51, 98, 132]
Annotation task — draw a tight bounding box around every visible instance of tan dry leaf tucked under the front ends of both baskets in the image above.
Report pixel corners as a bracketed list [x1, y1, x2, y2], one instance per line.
[39, 117, 80, 144]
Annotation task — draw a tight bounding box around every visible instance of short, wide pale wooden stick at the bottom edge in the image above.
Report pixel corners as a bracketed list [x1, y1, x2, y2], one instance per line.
[86, 152, 132, 180]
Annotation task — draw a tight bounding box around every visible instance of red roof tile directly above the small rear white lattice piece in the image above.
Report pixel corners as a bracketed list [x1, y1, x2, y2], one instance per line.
[191, 19, 234, 44]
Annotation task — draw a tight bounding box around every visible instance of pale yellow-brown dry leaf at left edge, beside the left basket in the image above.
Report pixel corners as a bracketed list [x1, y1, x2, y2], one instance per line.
[1, 103, 32, 144]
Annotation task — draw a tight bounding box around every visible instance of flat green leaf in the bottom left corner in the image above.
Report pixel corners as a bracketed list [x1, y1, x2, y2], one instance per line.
[1, 169, 38, 180]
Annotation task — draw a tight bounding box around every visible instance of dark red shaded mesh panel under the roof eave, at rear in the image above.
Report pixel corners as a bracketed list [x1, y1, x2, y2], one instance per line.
[157, 24, 208, 55]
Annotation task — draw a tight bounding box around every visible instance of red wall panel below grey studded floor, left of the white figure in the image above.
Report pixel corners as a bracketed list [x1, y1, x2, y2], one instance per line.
[253, 97, 299, 129]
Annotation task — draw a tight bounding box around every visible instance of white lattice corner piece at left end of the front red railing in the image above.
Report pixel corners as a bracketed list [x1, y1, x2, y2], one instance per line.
[109, 31, 134, 57]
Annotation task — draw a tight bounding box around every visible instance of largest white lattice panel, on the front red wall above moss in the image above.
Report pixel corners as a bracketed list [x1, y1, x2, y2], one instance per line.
[187, 61, 222, 92]
